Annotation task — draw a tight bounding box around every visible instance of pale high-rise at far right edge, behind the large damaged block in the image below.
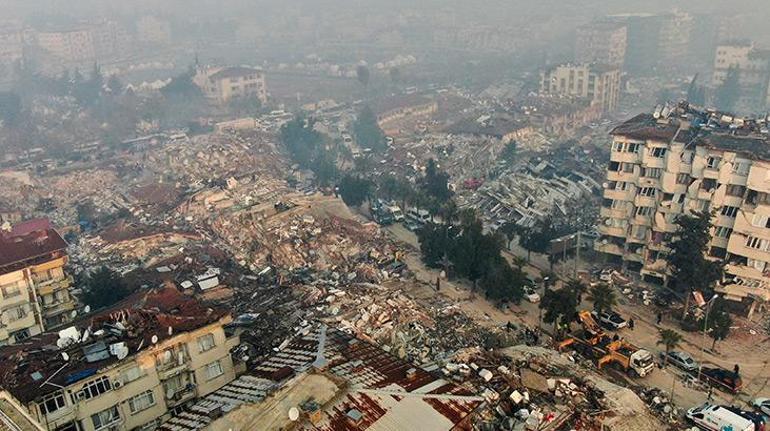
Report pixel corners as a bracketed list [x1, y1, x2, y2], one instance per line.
[712, 41, 770, 111]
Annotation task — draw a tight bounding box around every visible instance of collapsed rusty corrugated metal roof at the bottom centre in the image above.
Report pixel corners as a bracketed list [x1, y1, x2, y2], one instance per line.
[161, 325, 482, 431]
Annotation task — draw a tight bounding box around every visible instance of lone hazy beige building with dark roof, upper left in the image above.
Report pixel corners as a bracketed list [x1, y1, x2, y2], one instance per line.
[193, 66, 267, 104]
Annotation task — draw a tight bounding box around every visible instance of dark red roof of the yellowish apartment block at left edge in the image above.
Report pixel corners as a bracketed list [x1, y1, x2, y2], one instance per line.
[0, 219, 67, 275]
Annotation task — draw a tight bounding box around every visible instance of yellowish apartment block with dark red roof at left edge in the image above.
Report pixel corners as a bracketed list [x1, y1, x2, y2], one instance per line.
[0, 219, 75, 344]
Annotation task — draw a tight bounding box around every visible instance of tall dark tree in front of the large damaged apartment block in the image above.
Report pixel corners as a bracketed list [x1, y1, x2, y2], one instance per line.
[666, 212, 722, 318]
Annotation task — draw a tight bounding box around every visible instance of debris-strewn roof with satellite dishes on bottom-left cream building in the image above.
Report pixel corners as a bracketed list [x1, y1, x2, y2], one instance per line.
[0, 286, 228, 403]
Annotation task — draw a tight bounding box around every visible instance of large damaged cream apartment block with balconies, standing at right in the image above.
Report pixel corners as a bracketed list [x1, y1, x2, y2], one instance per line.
[595, 102, 770, 311]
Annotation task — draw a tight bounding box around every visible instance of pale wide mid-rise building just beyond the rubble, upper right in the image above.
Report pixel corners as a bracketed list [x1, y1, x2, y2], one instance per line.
[540, 63, 620, 113]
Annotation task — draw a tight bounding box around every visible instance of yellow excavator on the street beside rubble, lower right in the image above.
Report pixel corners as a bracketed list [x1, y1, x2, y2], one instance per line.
[558, 310, 655, 377]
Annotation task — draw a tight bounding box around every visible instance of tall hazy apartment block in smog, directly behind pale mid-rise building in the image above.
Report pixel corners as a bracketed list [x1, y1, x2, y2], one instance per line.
[575, 21, 628, 68]
